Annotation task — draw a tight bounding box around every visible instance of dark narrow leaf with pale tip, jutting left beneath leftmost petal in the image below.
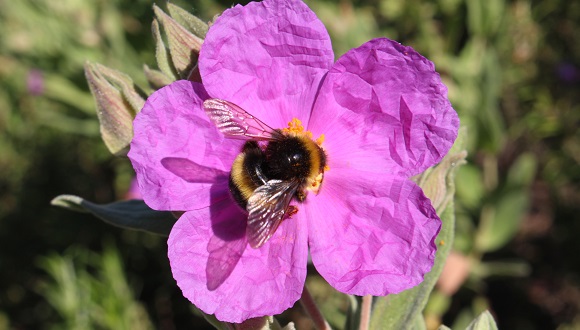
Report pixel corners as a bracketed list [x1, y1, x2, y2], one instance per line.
[50, 195, 177, 236]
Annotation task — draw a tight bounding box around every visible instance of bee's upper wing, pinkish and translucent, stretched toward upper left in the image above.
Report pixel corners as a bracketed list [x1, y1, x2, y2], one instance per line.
[203, 99, 282, 141]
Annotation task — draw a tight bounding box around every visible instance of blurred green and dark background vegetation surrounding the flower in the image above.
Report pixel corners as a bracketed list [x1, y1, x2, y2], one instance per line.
[0, 0, 580, 329]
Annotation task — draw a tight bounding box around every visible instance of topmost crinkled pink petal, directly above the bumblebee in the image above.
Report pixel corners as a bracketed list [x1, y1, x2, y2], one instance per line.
[199, 0, 334, 128]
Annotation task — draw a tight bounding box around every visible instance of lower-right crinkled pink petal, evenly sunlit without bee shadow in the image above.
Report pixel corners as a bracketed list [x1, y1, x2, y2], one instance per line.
[304, 168, 441, 296]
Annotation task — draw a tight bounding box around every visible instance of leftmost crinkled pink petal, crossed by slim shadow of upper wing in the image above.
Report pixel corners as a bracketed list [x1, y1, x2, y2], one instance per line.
[129, 80, 242, 211]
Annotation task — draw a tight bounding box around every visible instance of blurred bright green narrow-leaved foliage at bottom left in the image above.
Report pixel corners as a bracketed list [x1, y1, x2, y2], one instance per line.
[39, 246, 153, 329]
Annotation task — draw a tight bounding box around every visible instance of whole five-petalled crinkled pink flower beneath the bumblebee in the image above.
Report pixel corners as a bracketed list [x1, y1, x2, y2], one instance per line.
[129, 0, 459, 322]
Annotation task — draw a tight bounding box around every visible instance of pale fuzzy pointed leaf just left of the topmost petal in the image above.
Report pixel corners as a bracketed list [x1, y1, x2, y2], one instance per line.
[153, 5, 203, 78]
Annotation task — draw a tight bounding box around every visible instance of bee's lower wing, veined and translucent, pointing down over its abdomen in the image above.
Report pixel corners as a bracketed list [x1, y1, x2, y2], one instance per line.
[246, 180, 300, 248]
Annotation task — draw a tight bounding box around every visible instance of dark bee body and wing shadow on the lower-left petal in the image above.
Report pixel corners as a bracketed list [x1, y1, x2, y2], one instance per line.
[205, 183, 248, 291]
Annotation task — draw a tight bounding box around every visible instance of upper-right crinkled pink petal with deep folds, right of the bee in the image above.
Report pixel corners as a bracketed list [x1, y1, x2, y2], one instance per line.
[308, 38, 459, 177]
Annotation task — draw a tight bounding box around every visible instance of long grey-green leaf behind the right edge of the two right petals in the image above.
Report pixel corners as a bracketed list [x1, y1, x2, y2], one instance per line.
[370, 130, 467, 329]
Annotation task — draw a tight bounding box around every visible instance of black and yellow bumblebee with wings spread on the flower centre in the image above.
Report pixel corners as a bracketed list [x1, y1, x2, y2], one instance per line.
[203, 99, 326, 248]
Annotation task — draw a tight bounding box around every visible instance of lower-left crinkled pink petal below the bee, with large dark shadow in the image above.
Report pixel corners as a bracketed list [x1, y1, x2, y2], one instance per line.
[168, 200, 308, 323]
